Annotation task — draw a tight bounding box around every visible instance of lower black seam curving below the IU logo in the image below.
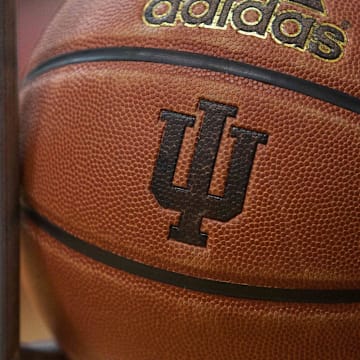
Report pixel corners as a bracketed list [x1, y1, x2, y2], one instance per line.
[22, 206, 360, 304]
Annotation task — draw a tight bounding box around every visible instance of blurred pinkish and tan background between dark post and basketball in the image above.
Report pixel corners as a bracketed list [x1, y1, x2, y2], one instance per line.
[16, 0, 64, 342]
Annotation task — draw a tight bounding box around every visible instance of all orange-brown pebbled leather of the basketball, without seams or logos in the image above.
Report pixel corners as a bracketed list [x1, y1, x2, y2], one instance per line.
[21, 0, 360, 360]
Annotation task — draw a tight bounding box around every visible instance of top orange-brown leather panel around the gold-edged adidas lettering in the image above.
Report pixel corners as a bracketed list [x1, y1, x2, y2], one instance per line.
[30, 0, 360, 97]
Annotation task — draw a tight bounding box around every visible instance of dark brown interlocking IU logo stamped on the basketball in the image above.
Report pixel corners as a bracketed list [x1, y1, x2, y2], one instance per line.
[151, 99, 268, 247]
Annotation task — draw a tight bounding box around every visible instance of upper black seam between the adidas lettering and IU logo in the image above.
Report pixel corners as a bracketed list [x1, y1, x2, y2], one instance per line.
[26, 47, 360, 114]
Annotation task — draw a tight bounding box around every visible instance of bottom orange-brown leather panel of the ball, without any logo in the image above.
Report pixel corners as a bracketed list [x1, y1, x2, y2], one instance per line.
[22, 223, 360, 360]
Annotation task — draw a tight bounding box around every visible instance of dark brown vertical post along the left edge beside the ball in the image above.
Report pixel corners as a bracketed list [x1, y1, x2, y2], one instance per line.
[0, 0, 19, 360]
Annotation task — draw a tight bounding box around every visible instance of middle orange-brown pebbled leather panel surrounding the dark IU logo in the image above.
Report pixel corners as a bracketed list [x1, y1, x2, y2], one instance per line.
[22, 63, 360, 289]
